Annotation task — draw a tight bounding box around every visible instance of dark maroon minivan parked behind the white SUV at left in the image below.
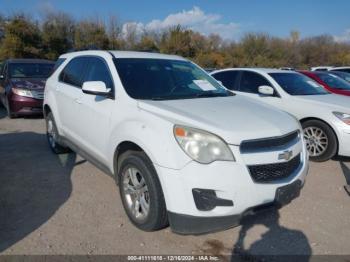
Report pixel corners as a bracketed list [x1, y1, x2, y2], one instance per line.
[0, 59, 54, 118]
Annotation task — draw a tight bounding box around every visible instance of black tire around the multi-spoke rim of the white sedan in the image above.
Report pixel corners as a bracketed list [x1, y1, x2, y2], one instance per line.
[302, 120, 338, 162]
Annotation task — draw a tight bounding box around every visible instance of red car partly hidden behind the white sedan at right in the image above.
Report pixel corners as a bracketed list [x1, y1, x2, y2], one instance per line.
[299, 71, 350, 96]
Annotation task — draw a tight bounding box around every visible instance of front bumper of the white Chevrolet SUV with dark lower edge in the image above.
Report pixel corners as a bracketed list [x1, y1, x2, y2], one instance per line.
[156, 143, 308, 234]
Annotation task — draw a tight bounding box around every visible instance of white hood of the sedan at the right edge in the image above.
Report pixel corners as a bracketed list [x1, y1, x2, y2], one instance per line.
[294, 94, 350, 113]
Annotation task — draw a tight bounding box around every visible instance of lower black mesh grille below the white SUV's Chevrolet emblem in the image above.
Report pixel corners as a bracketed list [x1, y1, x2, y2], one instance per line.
[248, 154, 301, 183]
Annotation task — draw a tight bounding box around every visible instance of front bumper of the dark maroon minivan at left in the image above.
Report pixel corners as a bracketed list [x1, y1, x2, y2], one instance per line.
[8, 94, 43, 115]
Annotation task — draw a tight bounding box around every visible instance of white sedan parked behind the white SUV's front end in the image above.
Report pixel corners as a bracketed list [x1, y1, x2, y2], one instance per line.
[211, 68, 350, 162]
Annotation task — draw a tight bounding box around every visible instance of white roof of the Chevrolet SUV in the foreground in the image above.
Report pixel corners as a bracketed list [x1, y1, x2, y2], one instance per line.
[60, 50, 187, 61]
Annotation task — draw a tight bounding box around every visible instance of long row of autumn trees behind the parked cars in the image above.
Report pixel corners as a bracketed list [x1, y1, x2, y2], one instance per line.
[0, 13, 350, 68]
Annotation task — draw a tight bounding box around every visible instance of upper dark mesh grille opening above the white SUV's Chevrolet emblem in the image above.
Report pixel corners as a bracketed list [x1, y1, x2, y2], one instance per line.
[240, 131, 299, 154]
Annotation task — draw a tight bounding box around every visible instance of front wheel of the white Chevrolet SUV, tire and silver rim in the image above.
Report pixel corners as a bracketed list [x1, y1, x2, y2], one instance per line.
[118, 151, 168, 231]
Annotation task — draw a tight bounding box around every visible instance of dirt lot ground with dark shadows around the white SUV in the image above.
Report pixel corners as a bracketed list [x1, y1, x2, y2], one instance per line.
[0, 109, 350, 255]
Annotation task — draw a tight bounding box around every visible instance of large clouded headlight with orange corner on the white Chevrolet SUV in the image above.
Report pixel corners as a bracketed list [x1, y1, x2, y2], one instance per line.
[174, 126, 235, 164]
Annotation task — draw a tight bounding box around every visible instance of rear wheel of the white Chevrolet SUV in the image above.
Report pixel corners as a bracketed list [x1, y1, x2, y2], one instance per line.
[45, 112, 70, 154]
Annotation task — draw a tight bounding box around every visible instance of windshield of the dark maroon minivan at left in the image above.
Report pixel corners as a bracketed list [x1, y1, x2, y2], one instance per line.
[9, 63, 54, 78]
